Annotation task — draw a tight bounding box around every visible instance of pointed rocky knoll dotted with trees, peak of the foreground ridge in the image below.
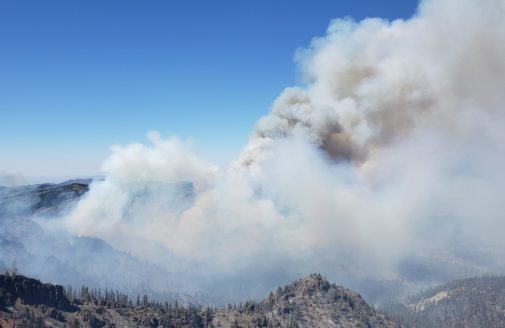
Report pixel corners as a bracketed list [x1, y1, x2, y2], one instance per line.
[215, 274, 400, 328]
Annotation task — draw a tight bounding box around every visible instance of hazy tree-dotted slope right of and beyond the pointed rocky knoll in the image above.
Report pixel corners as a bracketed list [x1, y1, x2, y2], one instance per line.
[383, 276, 505, 328]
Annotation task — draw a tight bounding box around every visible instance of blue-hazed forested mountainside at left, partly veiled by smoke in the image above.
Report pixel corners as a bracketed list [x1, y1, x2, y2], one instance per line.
[0, 180, 201, 299]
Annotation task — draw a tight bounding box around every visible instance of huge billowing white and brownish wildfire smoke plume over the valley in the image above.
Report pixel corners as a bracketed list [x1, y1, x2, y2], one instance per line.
[62, 0, 505, 302]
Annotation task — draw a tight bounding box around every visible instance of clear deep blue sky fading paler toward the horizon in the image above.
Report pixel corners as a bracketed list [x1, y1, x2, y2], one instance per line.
[0, 0, 417, 176]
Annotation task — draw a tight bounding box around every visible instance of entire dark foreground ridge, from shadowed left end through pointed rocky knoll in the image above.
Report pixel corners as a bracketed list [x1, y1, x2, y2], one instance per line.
[0, 274, 401, 328]
